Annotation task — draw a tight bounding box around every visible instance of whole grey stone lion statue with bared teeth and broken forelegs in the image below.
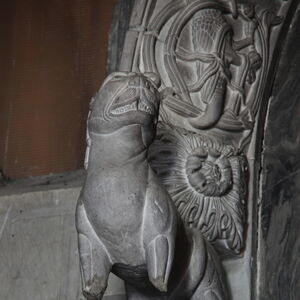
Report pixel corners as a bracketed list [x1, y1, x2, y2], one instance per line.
[76, 73, 227, 300]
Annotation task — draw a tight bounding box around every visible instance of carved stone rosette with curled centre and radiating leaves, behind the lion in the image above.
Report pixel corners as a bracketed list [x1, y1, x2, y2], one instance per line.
[149, 123, 247, 254]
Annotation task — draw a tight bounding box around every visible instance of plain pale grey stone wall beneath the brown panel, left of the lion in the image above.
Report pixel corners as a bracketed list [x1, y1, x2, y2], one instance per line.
[0, 171, 124, 300]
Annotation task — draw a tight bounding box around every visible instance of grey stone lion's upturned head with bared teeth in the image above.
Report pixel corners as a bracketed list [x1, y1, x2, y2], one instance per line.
[88, 72, 159, 133]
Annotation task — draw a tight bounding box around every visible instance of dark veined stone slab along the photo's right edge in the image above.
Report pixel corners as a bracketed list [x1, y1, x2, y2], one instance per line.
[257, 3, 300, 300]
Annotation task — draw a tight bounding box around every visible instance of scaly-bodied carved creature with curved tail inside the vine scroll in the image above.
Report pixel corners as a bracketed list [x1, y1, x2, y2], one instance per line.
[173, 9, 237, 128]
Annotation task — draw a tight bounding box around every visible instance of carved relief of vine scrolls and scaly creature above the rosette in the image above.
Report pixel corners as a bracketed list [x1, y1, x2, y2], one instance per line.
[133, 1, 281, 148]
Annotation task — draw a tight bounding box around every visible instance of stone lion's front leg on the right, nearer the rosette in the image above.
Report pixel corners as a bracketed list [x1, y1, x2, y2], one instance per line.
[143, 171, 177, 292]
